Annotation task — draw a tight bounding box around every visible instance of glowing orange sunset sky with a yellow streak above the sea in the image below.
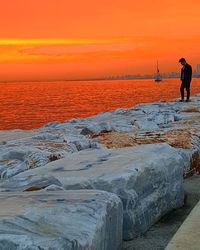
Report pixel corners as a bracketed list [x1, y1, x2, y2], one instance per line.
[0, 0, 200, 81]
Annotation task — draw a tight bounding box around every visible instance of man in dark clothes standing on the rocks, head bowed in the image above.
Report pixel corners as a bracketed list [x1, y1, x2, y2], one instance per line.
[179, 58, 192, 102]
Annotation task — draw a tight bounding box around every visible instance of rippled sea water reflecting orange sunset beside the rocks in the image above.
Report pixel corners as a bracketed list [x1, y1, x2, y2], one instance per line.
[0, 79, 200, 129]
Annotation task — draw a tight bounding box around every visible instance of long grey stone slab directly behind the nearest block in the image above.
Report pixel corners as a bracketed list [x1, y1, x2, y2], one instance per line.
[0, 144, 184, 240]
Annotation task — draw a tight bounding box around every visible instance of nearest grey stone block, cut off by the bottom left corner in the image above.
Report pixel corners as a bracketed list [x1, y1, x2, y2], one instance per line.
[0, 190, 122, 250]
